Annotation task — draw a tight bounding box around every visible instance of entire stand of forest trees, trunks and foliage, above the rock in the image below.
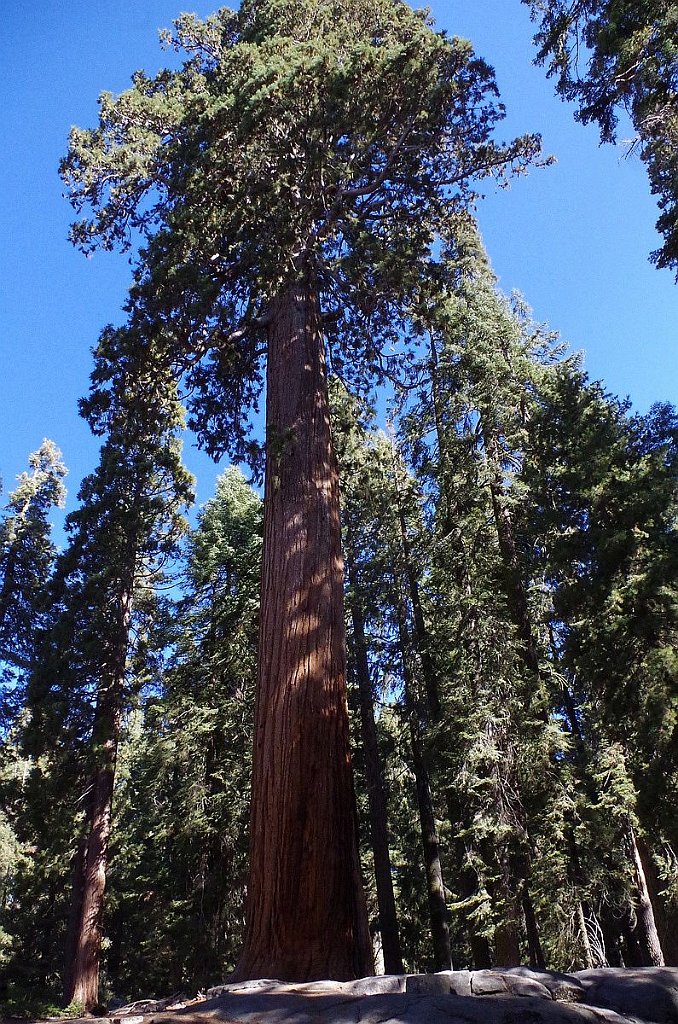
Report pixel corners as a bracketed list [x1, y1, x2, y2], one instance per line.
[0, 0, 678, 1010]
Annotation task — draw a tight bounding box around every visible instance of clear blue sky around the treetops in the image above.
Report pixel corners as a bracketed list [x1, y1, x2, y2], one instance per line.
[0, 0, 678, 524]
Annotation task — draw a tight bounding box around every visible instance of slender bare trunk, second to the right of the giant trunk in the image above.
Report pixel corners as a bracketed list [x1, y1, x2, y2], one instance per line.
[396, 599, 452, 971]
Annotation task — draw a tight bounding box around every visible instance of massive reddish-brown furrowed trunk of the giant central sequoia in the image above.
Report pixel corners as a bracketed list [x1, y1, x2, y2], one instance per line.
[234, 276, 373, 981]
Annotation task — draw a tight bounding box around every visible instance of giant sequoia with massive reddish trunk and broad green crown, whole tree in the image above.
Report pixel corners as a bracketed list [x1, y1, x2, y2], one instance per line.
[62, 0, 539, 979]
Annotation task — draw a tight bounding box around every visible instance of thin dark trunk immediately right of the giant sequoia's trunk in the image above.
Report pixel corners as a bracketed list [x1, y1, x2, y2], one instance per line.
[347, 559, 405, 974]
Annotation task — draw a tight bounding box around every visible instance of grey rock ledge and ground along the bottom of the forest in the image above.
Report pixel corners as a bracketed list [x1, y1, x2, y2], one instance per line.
[13, 968, 678, 1024]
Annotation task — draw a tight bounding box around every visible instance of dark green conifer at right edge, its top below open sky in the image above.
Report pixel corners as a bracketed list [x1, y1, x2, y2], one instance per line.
[526, 372, 678, 964]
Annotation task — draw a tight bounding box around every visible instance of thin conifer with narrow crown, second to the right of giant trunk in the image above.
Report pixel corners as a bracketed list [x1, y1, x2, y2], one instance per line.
[336, 397, 452, 970]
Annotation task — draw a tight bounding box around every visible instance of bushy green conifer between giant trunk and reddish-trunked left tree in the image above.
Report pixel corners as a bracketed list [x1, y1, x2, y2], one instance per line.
[107, 468, 261, 993]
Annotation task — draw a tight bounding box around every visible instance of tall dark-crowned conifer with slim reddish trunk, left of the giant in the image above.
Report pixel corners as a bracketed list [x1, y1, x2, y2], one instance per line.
[19, 329, 190, 1010]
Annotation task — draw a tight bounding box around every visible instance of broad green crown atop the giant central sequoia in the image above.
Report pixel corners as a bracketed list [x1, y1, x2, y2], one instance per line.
[61, 0, 539, 462]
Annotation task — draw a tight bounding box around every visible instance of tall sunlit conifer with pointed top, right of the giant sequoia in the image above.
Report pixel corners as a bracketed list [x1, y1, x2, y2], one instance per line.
[402, 228, 564, 967]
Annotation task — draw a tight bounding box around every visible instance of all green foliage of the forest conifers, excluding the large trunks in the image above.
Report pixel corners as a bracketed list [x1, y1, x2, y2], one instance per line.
[0, 0, 678, 987]
